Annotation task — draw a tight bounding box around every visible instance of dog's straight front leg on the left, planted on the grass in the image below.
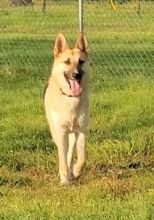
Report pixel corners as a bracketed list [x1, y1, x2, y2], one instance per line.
[57, 130, 69, 185]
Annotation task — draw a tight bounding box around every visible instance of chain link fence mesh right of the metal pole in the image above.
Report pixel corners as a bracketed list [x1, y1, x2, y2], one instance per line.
[84, 1, 154, 79]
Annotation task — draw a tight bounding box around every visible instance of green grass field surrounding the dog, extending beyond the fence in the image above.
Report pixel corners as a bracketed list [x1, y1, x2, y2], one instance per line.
[0, 1, 154, 220]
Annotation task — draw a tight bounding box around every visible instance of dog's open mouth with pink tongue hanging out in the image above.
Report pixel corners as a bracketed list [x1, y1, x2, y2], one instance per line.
[65, 75, 82, 96]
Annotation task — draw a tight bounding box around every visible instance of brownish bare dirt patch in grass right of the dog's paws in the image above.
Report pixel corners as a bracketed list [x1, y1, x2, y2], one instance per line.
[90, 157, 154, 195]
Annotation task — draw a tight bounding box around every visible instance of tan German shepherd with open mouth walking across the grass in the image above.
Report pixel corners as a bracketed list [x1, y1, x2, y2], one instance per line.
[44, 34, 89, 185]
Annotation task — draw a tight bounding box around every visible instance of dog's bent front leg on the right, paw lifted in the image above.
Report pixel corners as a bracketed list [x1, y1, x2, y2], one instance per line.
[73, 132, 86, 178]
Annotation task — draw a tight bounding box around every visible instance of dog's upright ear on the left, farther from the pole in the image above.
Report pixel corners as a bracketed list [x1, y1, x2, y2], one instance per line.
[54, 33, 69, 57]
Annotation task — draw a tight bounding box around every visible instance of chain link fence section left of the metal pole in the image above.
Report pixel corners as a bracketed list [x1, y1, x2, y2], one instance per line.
[0, 1, 78, 77]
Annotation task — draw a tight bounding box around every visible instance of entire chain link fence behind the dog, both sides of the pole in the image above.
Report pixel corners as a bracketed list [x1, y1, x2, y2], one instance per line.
[0, 0, 154, 81]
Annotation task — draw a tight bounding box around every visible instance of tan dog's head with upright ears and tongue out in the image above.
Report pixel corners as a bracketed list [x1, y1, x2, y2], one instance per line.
[52, 33, 88, 96]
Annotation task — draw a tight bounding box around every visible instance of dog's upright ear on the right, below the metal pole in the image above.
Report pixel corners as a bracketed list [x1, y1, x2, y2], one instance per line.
[75, 33, 88, 52]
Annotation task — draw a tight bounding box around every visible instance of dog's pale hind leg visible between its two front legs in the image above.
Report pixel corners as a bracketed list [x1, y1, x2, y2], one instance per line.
[67, 133, 76, 179]
